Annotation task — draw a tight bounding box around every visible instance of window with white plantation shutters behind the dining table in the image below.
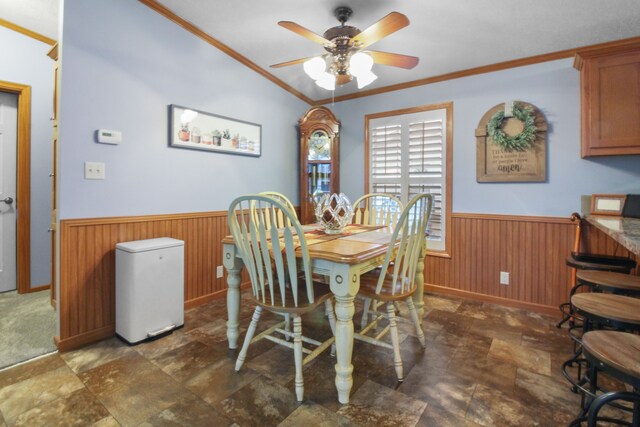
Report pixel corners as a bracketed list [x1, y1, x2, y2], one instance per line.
[367, 104, 451, 251]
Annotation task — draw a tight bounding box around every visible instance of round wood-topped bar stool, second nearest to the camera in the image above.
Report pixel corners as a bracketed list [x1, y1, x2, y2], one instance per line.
[562, 293, 640, 422]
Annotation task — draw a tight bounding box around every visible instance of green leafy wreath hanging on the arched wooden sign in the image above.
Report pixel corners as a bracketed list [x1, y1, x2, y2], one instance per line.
[487, 103, 538, 151]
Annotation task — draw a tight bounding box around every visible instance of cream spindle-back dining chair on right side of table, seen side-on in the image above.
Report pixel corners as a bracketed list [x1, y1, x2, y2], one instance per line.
[355, 194, 433, 382]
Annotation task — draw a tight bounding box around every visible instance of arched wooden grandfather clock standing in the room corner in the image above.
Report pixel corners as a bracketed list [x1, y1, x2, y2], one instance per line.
[298, 107, 340, 224]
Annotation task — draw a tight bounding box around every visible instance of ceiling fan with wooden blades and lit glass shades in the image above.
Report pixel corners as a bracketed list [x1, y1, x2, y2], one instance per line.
[271, 6, 419, 90]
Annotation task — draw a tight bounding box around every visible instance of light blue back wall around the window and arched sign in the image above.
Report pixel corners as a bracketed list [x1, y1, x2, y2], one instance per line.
[329, 59, 640, 217]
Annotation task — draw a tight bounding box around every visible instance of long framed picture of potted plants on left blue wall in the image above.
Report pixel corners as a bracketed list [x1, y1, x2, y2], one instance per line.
[169, 104, 262, 157]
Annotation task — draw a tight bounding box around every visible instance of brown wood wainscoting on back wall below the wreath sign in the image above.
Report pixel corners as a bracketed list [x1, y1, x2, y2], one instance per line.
[424, 213, 638, 313]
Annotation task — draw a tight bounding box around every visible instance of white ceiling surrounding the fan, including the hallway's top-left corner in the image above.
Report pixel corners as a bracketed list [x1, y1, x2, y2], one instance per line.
[0, 0, 640, 100]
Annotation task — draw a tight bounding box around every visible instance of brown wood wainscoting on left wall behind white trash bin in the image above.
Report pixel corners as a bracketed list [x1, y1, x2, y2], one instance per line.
[57, 211, 247, 349]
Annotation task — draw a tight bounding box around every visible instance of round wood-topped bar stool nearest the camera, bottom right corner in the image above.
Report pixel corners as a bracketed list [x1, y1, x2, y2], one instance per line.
[570, 331, 640, 427]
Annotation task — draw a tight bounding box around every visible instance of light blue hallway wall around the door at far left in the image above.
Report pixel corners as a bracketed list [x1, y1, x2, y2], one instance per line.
[0, 27, 53, 287]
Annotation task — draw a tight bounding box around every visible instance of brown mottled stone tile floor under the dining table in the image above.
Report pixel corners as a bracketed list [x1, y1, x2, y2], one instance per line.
[0, 294, 616, 426]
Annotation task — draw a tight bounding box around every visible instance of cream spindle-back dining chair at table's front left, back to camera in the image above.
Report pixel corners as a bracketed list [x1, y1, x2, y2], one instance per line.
[228, 195, 335, 401]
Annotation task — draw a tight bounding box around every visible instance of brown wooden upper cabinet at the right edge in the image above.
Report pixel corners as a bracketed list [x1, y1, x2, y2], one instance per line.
[574, 42, 640, 157]
